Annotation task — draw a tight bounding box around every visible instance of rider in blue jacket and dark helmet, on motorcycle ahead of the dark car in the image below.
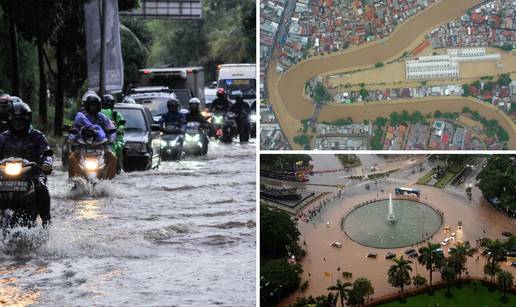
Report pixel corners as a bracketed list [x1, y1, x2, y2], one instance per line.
[68, 93, 117, 179]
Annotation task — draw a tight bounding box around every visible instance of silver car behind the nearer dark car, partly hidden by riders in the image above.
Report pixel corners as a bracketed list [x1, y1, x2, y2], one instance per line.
[123, 86, 188, 123]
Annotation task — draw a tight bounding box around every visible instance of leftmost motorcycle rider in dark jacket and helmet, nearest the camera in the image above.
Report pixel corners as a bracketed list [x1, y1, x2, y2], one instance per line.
[0, 101, 53, 226]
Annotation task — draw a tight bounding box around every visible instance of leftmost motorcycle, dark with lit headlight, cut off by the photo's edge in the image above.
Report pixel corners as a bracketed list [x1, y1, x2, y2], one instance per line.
[0, 157, 39, 229]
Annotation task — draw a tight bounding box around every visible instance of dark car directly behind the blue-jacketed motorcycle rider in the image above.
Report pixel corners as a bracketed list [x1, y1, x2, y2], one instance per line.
[114, 103, 161, 172]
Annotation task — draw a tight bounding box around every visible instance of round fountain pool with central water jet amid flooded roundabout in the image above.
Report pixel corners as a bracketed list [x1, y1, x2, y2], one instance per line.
[341, 195, 442, 248]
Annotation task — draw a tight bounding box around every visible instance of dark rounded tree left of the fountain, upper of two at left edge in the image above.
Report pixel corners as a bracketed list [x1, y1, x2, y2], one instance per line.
[260, 206, 301, 258]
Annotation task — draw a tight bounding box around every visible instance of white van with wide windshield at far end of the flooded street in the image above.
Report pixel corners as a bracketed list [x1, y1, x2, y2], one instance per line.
[217, 64, 257, 105]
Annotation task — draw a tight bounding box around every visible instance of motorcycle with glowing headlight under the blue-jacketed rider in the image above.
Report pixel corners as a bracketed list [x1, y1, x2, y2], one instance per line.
[70, 128, 115, 183]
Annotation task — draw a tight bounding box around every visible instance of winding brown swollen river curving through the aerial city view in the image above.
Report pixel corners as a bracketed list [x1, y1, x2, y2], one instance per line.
[267, 0, 516, 149]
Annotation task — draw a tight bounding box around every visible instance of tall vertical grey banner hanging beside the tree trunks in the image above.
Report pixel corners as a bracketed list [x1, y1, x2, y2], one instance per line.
[84, 0, 124, 93]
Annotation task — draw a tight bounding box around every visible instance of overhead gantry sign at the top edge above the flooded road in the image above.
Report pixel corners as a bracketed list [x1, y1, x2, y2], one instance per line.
[120, 0, 202, 19]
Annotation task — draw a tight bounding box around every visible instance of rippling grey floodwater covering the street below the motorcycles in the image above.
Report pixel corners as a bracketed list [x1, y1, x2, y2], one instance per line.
[0, 140, 256, 306]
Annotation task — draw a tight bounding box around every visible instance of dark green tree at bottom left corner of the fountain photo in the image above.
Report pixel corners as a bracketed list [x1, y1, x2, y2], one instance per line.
[260, 259, 303, 306]
